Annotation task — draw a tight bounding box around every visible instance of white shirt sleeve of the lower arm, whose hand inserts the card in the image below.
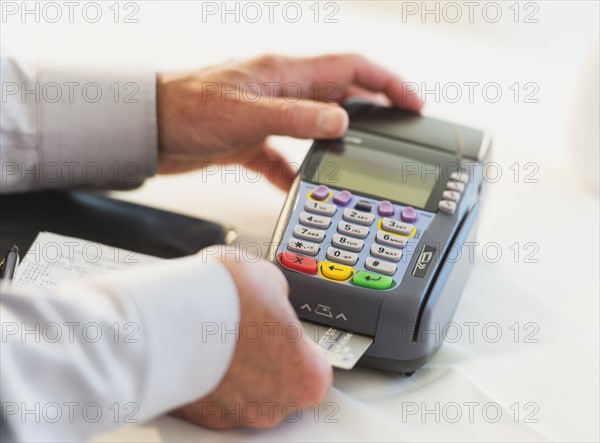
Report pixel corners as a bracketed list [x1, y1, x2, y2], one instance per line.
[0, 256, 239, 441]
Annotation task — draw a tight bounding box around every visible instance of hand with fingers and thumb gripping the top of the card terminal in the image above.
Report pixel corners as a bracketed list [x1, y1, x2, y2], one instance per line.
[157, 54, 421, 189]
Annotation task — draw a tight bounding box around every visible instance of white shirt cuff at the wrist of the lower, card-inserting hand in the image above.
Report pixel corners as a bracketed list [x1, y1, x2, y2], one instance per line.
[87, 255, 240, 420]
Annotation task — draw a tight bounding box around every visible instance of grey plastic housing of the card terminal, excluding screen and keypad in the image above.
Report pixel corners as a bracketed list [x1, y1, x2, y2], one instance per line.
[269, 103, 491, 374]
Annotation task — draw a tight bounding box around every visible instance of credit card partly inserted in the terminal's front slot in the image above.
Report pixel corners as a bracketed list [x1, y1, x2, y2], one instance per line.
[300, 320, 373, 369]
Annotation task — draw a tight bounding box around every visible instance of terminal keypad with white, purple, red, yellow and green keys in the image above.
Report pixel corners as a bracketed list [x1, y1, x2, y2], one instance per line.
[277, 182, 436, 291]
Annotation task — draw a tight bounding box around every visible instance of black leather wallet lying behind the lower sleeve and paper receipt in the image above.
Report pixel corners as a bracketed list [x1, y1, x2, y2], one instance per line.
[0, 191, 232, 258]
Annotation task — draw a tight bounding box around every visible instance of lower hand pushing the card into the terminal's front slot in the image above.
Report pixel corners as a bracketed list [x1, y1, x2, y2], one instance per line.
[172, 254, 332, 429]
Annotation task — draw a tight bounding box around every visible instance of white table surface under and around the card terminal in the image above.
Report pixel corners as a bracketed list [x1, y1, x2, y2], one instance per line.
[3, 2, 600, 441]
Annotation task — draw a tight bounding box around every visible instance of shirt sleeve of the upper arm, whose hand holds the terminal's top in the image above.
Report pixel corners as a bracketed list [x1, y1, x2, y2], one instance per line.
[0, 52, 158, 193]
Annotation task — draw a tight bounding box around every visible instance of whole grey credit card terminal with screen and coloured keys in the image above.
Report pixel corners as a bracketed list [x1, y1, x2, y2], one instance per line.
[269, 103, 491, 374]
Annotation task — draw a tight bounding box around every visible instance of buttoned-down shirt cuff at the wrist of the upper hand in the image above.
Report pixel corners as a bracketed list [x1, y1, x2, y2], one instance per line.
[34, 60, 158, 189]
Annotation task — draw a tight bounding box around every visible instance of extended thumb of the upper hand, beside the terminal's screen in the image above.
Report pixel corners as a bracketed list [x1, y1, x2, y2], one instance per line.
[255, 97, 349, 138]
